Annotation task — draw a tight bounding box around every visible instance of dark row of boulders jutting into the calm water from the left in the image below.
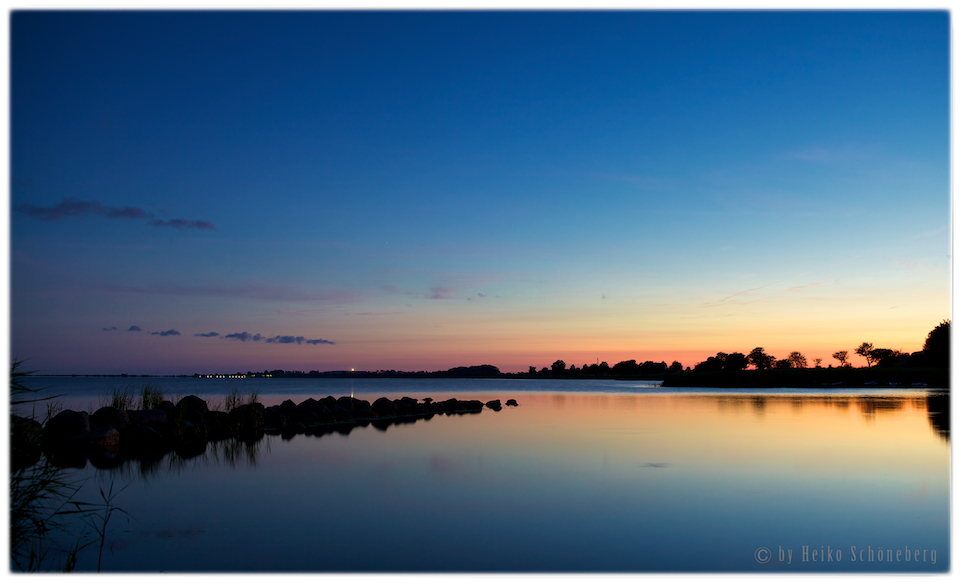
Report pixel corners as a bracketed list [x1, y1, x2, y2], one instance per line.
[10, 395, 517, 470]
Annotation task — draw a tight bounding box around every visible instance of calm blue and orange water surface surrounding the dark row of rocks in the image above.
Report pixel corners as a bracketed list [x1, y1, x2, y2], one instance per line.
[11, 378, 950, 573]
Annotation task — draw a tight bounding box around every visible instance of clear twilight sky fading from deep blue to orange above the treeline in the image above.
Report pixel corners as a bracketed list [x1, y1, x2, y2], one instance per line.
[9, 11, 951, 374]
